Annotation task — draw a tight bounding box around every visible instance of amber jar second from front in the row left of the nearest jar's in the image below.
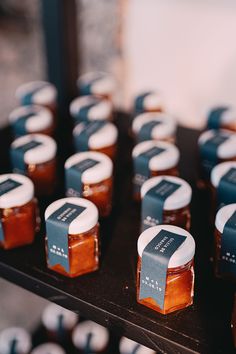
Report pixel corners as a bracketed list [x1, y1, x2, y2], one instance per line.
[65, 151, 113, 217]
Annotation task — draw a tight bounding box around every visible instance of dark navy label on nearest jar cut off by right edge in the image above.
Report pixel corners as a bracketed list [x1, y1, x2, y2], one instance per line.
[219, 211, 236, 276]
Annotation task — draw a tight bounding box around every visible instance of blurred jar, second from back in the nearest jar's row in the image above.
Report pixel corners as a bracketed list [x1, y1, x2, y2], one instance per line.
[132, 113, 176, 143]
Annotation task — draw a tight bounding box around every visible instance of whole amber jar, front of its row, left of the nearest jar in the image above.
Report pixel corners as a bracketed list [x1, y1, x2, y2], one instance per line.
[45, 198, 99, 278]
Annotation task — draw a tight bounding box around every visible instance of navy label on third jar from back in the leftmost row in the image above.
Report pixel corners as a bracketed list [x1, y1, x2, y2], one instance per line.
[10, 140, 42, 173]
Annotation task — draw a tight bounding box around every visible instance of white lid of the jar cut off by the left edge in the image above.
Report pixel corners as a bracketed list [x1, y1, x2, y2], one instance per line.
[0, 173, 34, 209]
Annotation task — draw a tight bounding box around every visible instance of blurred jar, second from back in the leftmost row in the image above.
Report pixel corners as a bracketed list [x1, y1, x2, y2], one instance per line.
[9, 105, 54, 137]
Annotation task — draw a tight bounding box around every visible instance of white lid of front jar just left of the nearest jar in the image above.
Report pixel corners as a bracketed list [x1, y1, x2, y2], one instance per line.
[45, 197, 98, 235]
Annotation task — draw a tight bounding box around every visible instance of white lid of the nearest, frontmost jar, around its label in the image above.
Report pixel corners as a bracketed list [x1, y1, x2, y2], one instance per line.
[138, 225, 195, 268]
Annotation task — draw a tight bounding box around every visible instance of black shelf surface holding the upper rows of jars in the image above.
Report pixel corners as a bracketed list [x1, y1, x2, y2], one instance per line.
[0, 115, 234, 354]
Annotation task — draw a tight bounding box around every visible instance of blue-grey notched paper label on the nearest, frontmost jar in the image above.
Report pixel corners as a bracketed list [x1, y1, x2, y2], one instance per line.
[139, 230, 186, 309]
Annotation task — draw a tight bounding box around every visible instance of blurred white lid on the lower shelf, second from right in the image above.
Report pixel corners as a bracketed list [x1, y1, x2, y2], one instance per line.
[72, 321, 109, 352]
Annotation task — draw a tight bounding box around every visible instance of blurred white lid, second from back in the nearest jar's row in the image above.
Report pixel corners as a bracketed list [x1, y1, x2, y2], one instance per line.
[132, 112, 176, 140]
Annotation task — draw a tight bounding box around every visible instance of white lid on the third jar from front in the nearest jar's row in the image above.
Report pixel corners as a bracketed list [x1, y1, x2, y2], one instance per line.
[132, 140, 180, 171]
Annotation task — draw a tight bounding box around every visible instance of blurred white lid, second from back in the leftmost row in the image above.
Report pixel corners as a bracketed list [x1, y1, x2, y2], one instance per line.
[9, 105, 53, 133]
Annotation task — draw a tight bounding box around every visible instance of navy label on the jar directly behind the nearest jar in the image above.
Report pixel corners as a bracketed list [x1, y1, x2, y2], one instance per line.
[142, 179, 181, 231]
